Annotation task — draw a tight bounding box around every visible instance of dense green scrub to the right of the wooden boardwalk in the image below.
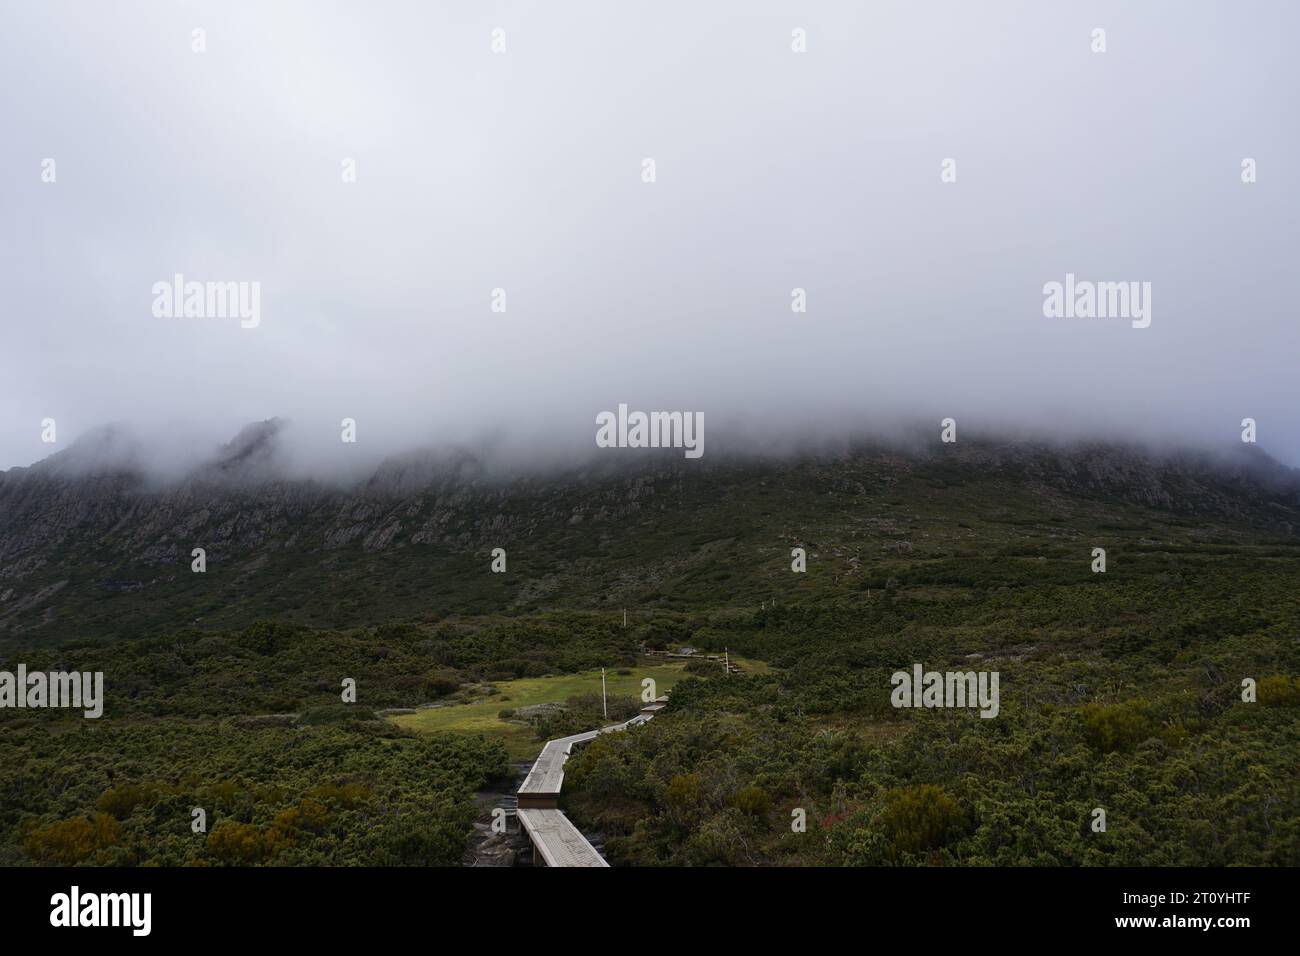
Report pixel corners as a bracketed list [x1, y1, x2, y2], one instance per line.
[566, 549, 1300, 865]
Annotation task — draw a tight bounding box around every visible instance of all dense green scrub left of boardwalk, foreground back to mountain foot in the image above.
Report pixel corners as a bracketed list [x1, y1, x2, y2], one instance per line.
[0, 623, 538, 865]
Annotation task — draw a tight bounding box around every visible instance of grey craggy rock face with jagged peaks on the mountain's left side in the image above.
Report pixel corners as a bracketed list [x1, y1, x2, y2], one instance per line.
[0, 421, 691, 578]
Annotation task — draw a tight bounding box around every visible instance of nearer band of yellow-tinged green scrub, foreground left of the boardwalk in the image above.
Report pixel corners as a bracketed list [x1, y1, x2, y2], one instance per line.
[10, 719, 507, 866]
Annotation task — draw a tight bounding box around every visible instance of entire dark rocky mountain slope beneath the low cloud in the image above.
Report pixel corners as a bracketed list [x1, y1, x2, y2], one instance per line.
[0, 420, 1300, 643]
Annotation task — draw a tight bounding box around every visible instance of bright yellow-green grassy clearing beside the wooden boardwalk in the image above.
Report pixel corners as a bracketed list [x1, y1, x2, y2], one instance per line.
[390, 663, 685, 760]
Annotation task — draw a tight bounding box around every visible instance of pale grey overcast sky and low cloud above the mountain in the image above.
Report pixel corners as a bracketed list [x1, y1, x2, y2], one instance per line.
[0, 0, 1300, 467]
